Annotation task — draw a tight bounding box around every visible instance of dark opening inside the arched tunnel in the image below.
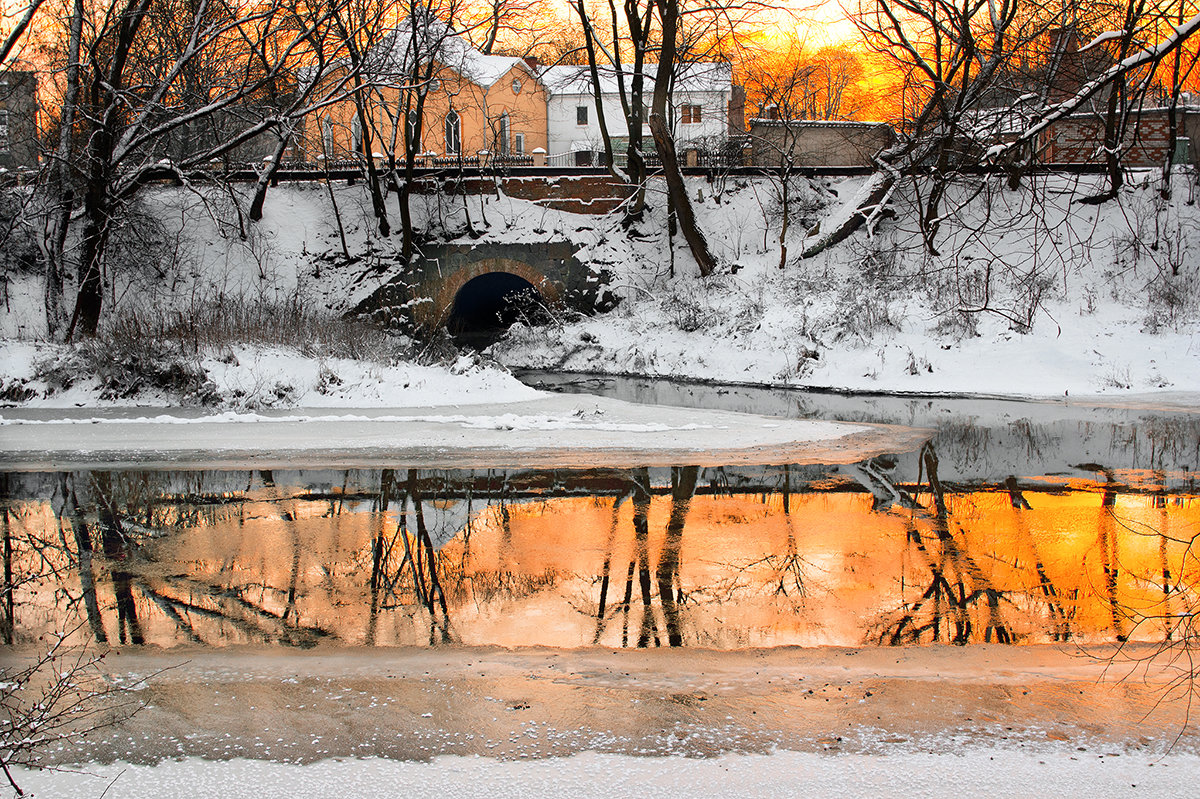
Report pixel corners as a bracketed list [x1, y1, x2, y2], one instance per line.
[446, 272, 546, 349]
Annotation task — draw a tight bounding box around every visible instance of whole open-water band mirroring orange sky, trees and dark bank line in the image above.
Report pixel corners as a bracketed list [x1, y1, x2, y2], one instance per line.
[0, 445, 1200, 648]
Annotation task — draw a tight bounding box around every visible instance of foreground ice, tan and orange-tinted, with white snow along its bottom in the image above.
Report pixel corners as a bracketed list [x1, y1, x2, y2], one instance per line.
[9, 645, 1200, 799]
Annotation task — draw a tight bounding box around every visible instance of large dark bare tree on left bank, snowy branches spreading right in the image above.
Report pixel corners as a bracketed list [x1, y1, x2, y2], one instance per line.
[38, 0, 364, 338]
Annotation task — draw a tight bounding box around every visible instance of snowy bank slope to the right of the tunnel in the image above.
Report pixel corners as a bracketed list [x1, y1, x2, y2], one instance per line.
[494, 169, 1200, 396]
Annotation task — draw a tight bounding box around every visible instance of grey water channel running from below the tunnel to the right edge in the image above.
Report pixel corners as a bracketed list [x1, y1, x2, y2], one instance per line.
[523, 372, 1200, 482]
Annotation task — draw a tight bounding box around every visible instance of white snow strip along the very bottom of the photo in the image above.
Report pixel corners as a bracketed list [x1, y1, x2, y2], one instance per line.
[14, 749, 1200, 799]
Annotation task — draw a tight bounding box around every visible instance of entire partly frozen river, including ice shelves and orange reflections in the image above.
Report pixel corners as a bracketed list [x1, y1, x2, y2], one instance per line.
[0, 376, 1200, 795]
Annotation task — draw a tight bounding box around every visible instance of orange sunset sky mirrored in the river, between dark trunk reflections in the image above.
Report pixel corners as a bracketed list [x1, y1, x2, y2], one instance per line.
[14, 475, 1200, 648]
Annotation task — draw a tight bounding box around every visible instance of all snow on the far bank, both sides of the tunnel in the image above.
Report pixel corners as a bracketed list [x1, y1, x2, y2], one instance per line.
[0, 173, 1200, 407]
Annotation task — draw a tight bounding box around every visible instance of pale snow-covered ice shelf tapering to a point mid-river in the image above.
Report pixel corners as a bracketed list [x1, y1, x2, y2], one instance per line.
[0, 395, 926, 469]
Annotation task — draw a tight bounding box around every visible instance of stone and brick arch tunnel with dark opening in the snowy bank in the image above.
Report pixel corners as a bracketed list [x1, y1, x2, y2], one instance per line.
[353, 241, 608, 343]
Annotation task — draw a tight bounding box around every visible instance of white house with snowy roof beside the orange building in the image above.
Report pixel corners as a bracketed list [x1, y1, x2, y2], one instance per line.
[539, 61, 740, 166]
